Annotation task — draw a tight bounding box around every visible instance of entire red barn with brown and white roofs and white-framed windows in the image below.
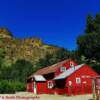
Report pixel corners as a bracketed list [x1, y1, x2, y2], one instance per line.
[27, 59, 97, 95]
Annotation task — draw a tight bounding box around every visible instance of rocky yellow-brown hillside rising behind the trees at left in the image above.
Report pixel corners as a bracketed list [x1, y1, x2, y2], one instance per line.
[0, 28, 60, 65]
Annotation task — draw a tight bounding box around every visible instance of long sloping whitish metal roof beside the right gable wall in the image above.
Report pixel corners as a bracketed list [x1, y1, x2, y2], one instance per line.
[54, 64, 84, 80]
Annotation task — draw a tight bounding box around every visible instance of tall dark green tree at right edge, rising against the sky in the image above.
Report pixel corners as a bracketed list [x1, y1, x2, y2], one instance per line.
[77, 14, 100, 72]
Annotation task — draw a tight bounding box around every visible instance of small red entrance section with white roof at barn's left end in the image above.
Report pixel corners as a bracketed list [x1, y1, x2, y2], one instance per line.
[27, 75, 47, 94]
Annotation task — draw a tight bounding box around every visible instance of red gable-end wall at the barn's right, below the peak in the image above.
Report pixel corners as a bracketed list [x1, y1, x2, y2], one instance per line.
[66, 65, 97, 95]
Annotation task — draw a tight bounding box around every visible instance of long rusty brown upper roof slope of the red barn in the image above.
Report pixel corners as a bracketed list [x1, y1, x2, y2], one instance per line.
[28, 59, 71, 79]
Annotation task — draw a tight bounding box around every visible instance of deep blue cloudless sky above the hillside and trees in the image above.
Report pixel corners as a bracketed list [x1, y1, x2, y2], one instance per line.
[0, 0, 100, 50]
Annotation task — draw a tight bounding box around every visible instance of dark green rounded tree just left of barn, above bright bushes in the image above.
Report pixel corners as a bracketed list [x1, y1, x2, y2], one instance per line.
[10, 60, 33, 83]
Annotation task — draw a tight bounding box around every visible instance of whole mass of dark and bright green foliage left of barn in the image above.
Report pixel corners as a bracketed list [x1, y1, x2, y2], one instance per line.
[0, 60, 33, 93]
